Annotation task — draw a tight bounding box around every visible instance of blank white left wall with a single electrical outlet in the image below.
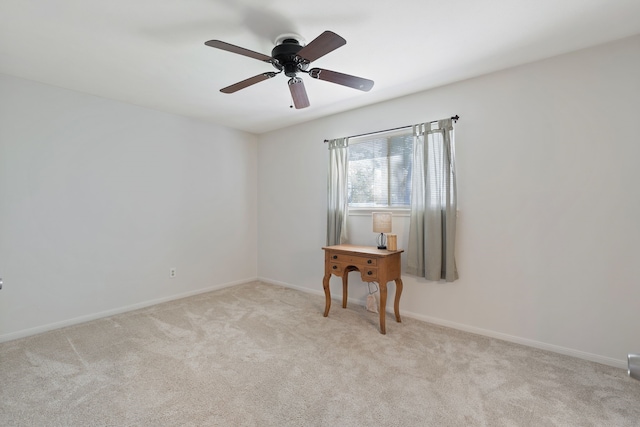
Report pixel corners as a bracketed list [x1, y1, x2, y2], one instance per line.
[0, 75, 257, 341]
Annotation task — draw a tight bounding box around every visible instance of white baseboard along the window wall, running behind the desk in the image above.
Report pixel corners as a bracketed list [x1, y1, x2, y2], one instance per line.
[258, 277, 627, 370]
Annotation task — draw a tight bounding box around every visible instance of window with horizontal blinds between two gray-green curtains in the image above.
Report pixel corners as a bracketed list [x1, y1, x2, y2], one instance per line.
[348, 128, 413, 208]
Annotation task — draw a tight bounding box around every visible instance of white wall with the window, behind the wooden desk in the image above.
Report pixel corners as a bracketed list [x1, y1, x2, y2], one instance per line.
[258, 36, 640, 367]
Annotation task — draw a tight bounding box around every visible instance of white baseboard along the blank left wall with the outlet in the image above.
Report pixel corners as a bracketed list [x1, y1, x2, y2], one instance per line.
[0, 277, 258, 343]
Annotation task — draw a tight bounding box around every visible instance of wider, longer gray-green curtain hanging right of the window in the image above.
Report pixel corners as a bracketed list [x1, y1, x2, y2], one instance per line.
[407, 119, 458, 282]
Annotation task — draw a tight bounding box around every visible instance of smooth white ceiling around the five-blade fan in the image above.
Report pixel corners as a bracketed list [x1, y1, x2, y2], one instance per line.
[0, 0, 640, 133]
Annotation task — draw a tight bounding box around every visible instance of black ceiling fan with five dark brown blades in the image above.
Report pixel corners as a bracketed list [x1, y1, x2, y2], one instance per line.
[205, 31, 373, 109]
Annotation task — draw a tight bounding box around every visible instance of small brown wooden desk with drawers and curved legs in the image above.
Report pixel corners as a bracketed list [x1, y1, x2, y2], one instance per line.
[322, 245, 403, 334]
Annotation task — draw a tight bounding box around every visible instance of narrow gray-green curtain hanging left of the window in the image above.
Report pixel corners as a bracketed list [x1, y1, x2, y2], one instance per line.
[327, 138, 349, 246]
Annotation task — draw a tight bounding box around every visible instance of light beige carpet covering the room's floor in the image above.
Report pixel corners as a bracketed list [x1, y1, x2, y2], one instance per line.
[0, 282, 640, 427]
